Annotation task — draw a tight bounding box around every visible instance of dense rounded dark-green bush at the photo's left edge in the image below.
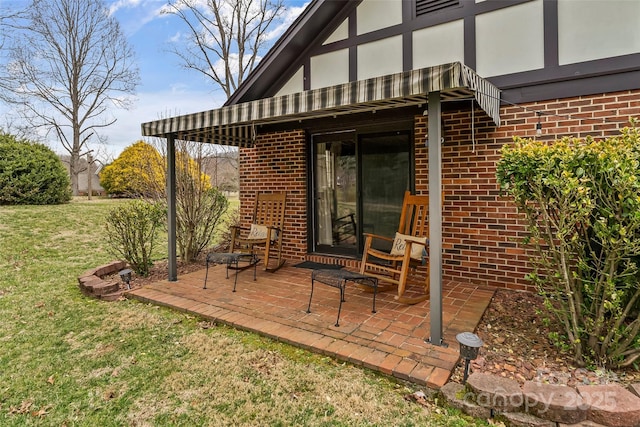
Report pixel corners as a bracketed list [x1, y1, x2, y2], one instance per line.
[0, 131, 71, 205]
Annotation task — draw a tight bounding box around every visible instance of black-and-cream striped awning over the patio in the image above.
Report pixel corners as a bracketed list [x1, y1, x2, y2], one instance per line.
[142, 62, 500, 147]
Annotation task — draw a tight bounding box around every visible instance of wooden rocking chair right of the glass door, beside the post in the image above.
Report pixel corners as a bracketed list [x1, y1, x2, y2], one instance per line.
[360, 191, 429, 304]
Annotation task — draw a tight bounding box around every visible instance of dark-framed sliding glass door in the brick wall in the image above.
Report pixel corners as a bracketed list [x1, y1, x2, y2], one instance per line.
[312, 131, 411, 256]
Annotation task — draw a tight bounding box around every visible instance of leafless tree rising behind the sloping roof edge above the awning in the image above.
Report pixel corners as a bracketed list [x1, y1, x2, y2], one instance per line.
[164, 0, 284, 98]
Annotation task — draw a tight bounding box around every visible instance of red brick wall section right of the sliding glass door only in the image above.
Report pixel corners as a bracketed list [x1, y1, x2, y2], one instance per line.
[432, 90, 640, 290]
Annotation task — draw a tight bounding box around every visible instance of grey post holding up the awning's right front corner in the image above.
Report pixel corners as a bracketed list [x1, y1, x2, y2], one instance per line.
[428, 92, 446, 346]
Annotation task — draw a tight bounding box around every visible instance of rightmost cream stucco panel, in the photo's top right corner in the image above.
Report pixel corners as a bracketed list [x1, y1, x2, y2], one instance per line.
[558, 0, 640, 65]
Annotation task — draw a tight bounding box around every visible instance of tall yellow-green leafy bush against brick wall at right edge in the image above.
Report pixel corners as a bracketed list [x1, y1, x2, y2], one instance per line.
[497, 122, 640, 367]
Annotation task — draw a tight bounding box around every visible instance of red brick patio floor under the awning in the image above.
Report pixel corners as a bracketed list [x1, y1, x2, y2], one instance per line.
[128, 263, 494, 388]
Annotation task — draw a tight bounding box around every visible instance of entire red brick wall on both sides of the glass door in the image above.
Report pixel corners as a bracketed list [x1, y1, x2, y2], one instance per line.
[240, 90, 640, 290]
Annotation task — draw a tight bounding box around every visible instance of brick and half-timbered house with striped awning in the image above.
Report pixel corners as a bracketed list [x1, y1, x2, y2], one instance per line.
[142, 0, 640, 290]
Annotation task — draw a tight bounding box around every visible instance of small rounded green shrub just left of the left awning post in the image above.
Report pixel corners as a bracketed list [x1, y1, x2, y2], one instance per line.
[105, 200, 166, 276]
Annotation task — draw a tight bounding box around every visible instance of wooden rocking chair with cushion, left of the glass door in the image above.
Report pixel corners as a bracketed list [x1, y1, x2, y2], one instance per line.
[230, 193, 287, 272]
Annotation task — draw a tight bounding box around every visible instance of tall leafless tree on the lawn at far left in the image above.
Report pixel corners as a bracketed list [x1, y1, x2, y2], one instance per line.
[0, 0, 139, 195]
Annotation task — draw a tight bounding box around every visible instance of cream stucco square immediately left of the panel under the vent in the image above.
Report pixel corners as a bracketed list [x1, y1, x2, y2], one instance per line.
[358, 36, 402, 80]
